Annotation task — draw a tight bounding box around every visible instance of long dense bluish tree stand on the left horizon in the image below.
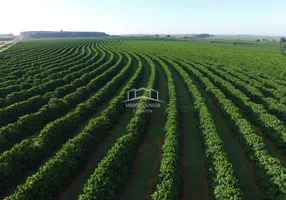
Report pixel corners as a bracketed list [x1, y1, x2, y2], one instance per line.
[20, 30, 109, 38]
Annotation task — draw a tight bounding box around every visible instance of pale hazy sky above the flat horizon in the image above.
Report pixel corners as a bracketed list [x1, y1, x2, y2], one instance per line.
[0, 0, 286, 36]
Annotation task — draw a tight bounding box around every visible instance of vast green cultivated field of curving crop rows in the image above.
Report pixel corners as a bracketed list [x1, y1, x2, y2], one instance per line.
[0, 38, 286, 200]
